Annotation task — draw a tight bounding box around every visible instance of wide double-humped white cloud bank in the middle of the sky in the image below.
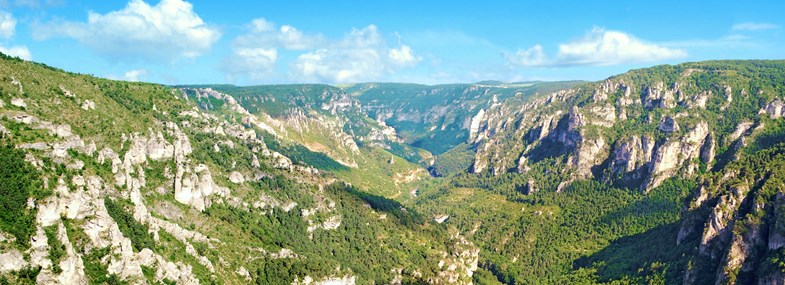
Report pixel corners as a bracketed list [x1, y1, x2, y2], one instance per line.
[221, 18, 421, 83]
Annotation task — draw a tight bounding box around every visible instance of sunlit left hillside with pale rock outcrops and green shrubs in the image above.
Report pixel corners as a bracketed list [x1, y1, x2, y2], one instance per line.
[0, 53, 476, 284]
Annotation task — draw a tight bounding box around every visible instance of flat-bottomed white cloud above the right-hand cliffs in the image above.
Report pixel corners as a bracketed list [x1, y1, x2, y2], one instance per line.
[507, 28, 687, 66]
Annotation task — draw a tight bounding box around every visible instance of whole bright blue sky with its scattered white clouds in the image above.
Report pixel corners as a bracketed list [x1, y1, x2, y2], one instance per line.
[0, 0, 785, 85]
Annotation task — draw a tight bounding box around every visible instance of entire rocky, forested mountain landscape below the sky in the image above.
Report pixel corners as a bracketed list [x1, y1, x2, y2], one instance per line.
[0, 51, 785, 284]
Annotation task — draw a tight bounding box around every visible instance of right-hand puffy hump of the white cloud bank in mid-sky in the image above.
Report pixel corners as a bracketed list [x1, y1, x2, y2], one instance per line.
[292, 25, 420, 83]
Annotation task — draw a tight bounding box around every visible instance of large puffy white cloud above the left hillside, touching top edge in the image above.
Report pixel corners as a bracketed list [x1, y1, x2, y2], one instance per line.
[33, 0, 220, 60]
